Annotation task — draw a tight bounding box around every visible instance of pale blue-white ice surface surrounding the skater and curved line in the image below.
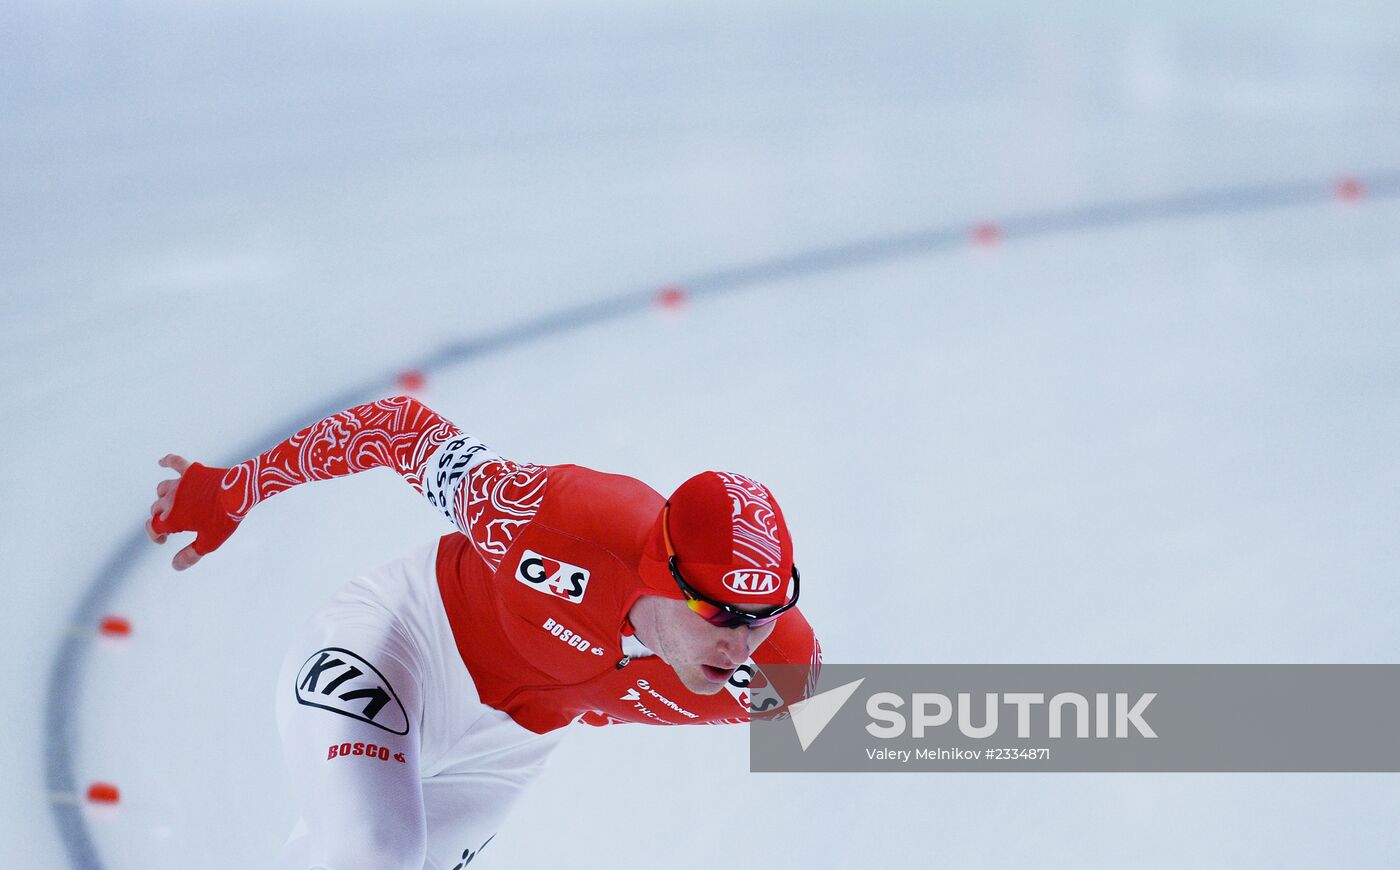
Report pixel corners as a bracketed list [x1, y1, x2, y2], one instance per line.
[0, 1, 1400, 870]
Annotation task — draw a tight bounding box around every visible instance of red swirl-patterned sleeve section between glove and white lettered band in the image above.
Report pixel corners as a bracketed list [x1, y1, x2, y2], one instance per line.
[220, 396, 459, 520]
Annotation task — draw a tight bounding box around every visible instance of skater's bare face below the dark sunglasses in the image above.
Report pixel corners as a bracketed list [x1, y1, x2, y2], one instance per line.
[631, 595, 776, 695]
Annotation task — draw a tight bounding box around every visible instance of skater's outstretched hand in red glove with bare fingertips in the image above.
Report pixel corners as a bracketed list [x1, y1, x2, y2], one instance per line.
[146, 454, 239, 572]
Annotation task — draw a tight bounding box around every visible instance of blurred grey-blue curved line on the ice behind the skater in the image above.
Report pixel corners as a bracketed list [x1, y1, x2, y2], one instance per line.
[43, 172, 1400, 870]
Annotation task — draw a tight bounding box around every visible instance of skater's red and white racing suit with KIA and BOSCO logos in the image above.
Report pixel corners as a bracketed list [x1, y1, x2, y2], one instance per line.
[167, 396, 820, 870]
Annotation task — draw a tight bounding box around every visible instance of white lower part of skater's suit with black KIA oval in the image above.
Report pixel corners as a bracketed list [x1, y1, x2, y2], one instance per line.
[274, 542, 564, 870]
